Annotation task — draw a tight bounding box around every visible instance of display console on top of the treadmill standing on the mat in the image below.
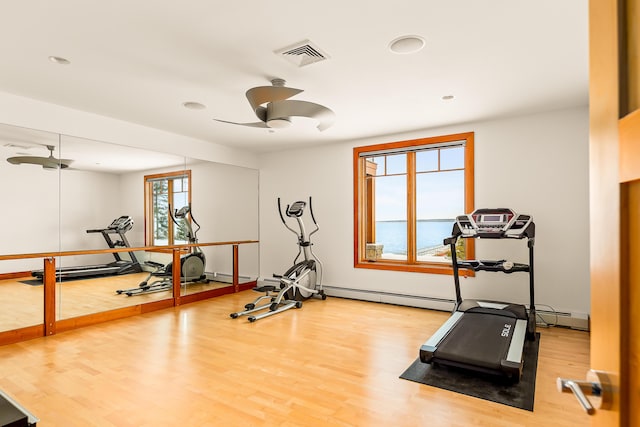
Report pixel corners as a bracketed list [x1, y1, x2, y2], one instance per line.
[456, 208, 533, 239]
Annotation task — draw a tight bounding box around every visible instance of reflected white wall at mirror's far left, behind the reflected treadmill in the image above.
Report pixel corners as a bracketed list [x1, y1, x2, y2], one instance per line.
[0, 162, 119, 273]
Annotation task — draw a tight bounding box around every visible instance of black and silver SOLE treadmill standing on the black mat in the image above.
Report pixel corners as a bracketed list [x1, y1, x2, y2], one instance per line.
[420, 208, 536, 382]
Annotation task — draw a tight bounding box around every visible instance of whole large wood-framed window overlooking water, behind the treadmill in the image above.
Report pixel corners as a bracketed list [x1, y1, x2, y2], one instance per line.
[353, 132, 474, 274]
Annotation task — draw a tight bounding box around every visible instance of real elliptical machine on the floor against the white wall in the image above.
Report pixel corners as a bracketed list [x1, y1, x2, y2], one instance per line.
[229, 197, 327, 322]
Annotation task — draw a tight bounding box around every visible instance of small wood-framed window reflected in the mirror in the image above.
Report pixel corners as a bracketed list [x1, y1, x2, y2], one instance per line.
[144, 170, 191, 246]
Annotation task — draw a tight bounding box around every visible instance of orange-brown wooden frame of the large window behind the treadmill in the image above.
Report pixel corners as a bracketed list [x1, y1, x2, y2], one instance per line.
[353, 132, 475, 276]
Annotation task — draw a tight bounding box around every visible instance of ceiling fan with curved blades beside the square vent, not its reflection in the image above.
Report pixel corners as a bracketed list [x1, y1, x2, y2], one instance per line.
[214, 79, 335, 131]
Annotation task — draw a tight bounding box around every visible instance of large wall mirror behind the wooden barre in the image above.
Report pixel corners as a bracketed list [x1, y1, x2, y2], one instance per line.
[0, 124, 259, 331]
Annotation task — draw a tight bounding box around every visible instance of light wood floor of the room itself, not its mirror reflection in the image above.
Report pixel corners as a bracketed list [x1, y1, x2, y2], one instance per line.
[0, 291, 589, 427]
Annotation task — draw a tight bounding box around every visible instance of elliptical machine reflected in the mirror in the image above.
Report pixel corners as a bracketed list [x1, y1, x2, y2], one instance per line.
[116, 204, 209, 296]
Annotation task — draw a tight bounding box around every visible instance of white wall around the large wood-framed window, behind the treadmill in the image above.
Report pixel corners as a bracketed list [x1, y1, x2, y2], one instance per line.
[259, 108, 590, 316]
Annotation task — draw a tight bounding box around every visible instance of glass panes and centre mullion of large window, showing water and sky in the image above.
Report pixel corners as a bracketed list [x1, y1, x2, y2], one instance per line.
[366, 145, 465, 262]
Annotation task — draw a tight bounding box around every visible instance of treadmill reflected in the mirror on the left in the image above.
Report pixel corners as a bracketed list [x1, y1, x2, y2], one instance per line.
[31, 215, 142, 280]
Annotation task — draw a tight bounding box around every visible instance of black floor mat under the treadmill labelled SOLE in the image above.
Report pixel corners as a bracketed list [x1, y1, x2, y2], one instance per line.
[400, 333, 540, 411]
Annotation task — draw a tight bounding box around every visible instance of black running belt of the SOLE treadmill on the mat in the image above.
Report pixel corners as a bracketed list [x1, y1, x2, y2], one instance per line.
[434, 312, 516, 370]
